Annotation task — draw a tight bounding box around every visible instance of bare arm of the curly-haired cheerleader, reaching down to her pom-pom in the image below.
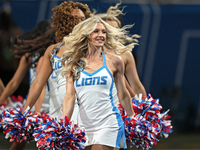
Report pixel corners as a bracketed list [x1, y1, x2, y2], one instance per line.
[23, 45, 54, 111]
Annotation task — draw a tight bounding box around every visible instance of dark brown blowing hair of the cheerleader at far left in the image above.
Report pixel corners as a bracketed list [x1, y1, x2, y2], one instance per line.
[11, 20, 56, 67]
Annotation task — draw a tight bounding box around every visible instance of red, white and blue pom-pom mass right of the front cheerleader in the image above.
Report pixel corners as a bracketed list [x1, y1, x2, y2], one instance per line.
[118, 94, 172, 149]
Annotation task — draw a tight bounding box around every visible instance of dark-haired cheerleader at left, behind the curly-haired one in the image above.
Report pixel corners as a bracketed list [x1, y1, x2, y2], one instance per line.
[0, 20, 55, 150]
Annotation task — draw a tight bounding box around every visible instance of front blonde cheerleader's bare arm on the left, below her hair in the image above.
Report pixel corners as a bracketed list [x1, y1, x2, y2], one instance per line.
[62, 72, 75, 119]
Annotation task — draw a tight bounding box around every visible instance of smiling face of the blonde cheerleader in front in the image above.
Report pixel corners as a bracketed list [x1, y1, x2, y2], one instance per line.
[89, 22, 106, 48]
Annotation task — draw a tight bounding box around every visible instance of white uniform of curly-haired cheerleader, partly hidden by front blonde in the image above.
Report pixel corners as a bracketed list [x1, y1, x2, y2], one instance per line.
[50, 43, 79, 123]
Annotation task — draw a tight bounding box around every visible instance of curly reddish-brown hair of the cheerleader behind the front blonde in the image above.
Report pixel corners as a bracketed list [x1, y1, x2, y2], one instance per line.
[52, 1, 91, 42]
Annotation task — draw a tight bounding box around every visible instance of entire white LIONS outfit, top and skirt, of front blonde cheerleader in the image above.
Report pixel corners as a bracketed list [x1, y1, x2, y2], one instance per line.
[74, 52, 126, 148]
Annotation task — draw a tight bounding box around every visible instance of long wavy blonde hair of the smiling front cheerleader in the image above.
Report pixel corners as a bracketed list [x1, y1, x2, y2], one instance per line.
[61, 16, 135, 79]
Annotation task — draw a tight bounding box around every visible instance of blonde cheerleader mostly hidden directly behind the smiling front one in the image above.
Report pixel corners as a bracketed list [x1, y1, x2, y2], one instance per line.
[97, 3, 147, 97]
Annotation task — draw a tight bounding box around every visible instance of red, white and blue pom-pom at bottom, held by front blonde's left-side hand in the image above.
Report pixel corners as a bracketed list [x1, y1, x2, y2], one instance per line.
[33, 117, 86, 150]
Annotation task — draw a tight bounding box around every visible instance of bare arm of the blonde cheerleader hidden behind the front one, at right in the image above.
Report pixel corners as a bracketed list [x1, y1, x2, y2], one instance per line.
[121, 51, 146, 96]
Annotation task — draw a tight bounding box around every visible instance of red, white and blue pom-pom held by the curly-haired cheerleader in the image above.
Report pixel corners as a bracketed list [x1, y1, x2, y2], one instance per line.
[1, 108, 42, 142]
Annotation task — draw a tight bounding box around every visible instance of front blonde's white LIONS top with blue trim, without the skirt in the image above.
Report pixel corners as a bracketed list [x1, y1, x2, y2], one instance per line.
[74, 52, 123, 131]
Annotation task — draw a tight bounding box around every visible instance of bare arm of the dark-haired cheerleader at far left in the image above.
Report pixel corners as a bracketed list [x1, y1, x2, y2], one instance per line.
[0, 55, 28, 104]
